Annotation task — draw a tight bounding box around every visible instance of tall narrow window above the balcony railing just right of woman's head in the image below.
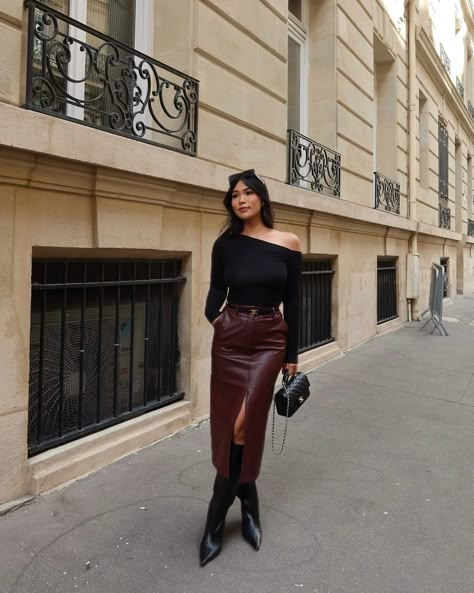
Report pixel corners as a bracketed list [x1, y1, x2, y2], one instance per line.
[287, 0, 307, 133]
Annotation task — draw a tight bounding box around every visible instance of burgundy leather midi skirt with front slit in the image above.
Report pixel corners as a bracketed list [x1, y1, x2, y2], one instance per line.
[211, 306, 288, 483]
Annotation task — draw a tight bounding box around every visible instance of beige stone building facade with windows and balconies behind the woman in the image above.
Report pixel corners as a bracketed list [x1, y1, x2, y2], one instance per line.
[0, 0, 474, 503]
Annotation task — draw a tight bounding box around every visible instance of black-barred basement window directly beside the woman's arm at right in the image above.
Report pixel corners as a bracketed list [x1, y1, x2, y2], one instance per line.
[298, 259, 334, 352]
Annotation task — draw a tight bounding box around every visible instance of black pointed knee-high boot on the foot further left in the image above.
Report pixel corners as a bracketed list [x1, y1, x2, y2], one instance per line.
[199, 443, 244, 566]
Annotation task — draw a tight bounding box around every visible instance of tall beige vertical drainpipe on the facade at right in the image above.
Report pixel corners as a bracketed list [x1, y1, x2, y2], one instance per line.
[405, 0, 420, 321]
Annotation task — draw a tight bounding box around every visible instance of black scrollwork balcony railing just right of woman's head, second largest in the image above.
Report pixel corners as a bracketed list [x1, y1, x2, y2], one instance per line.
[288, 130, 341, 198]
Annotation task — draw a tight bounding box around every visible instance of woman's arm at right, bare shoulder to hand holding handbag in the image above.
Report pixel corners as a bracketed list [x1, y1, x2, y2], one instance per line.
[283, 235, 302, 375]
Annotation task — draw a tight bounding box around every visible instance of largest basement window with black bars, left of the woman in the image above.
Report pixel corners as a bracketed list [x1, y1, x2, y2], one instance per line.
[28, 259, 185, 455]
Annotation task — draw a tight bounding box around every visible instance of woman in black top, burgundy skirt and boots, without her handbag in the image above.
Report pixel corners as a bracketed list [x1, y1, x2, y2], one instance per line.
[200, 169, 301, 566]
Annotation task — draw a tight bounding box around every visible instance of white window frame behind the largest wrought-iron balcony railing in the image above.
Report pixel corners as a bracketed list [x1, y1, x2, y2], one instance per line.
[66, 0, 154, 125]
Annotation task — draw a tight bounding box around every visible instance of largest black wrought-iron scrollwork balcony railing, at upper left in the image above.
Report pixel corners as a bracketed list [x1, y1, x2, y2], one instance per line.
[25, 0, 199, 155]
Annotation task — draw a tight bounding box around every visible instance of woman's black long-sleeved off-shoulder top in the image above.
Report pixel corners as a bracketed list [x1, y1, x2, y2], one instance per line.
[205, 234, 302, 363]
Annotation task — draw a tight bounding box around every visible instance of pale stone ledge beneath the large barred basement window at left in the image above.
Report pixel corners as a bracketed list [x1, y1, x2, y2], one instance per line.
[29, 401, 191, 494]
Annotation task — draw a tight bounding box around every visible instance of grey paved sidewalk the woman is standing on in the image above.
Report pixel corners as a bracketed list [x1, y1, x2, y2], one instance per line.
[0, 295, 474, 593]
